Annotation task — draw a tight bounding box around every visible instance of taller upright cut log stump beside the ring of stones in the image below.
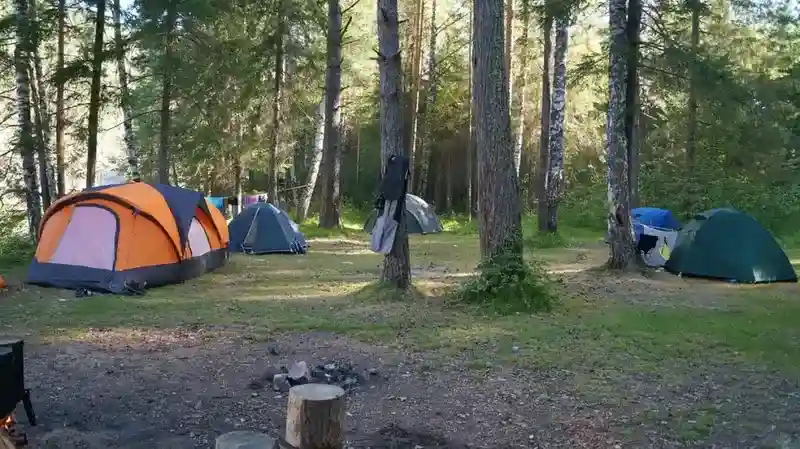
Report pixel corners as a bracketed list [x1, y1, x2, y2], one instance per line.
[286, 384, 345, 449]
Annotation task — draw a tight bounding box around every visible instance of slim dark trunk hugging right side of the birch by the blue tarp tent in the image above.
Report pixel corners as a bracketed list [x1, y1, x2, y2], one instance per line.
[625, 0, 642, 208]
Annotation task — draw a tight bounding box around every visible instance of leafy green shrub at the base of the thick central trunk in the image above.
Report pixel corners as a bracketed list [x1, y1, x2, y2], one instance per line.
[456, 236, 557, 315]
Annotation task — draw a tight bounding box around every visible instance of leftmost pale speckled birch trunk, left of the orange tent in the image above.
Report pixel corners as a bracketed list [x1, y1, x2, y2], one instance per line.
[14, 0, 42, 242]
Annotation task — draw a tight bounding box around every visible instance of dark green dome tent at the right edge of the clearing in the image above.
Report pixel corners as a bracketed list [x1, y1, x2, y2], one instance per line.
[664, 209, 797, 283]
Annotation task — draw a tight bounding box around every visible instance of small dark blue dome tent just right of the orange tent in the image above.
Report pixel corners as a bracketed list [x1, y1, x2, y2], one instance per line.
[228, 202, 308, 254]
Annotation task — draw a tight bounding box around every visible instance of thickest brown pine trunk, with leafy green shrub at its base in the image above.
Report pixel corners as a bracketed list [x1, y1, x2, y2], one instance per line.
[474, 0, 522, 259]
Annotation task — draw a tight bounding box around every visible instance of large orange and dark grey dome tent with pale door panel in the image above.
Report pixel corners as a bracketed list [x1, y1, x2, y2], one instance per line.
[28, 182, 229, 294]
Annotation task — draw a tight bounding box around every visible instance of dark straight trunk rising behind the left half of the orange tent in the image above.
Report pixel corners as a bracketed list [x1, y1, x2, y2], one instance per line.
[86, 0, 106, 189]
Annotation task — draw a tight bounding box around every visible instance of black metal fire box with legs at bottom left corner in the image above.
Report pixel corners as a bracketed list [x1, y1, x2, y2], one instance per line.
[0, 339, 36, 449]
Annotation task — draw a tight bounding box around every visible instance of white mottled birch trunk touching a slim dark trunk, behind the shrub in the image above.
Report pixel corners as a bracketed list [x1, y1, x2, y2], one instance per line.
[546, 13, 569, 232]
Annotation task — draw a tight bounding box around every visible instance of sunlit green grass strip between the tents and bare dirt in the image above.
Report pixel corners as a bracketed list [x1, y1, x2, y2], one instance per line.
[0, 234, 800, 377]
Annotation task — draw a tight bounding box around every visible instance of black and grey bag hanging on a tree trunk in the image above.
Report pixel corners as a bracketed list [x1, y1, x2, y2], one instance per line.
[372, 154, 410, 254]
